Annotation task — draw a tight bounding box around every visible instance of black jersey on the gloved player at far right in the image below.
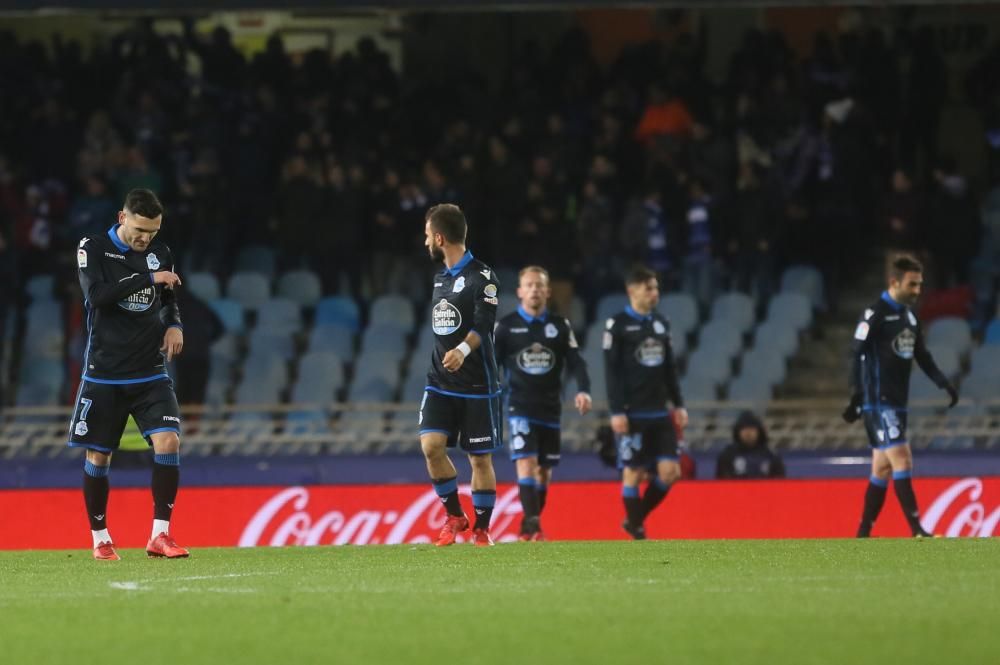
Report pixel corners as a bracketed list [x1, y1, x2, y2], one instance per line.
[849, 292, 948, 410]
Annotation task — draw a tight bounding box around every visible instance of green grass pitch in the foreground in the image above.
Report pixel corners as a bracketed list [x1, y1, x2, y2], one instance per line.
[0, 539, 1000, 665]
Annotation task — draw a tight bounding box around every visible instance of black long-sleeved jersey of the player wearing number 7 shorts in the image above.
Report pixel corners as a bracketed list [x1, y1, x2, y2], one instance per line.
[76, 224, 181, 383]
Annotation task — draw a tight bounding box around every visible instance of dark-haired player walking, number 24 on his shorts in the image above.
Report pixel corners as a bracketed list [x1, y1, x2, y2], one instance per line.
[603, 267, 688, 540]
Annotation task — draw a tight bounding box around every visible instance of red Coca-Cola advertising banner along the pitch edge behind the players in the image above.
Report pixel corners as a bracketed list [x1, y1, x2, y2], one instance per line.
[0, 477, 1000, 549]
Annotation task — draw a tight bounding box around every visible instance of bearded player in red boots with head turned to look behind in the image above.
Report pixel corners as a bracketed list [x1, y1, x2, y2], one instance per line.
[419, 203, 503, 547]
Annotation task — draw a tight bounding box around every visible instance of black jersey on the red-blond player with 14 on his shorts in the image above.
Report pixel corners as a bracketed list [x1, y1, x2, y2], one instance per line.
[496, 307, 590, 425]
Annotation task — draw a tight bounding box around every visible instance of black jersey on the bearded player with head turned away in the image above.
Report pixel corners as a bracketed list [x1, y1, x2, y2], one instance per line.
[427, 252, 500, 396]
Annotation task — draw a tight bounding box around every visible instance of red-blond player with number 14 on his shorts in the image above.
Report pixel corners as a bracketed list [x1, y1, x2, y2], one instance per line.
[496, 266, 591, 540]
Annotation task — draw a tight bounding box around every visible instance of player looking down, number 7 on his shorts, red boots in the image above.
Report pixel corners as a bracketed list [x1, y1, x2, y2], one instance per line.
[69, 189, 188, 560]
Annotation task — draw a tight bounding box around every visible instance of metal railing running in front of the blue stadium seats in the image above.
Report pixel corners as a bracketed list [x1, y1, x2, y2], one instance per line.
[0, 399, 1000, 458]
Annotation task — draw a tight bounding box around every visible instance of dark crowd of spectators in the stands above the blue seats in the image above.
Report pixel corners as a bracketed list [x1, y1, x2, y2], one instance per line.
[0, 16, 1000, 326]
